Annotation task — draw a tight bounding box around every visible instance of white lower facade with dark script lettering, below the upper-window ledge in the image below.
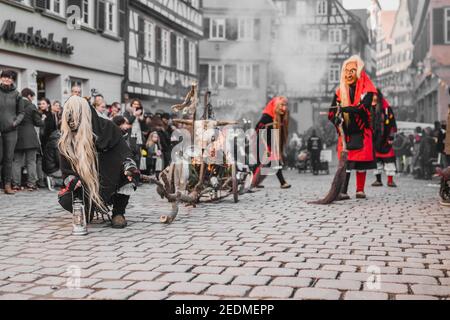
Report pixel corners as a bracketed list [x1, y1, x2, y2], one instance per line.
[0, 2, 124, 103]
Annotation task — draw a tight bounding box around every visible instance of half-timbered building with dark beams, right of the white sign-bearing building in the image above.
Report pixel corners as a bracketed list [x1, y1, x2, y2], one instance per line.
[123, 0, 203, 112]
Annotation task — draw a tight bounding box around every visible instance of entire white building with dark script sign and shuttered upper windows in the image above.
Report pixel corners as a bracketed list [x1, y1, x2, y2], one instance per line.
[0, 0, 126, 103]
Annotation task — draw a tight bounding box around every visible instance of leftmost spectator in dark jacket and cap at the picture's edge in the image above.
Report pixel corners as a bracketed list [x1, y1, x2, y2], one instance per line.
[0, 70, 25, 195]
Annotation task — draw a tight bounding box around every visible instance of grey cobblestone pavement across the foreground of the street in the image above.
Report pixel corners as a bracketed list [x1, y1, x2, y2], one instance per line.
[0, 172, 450, 299]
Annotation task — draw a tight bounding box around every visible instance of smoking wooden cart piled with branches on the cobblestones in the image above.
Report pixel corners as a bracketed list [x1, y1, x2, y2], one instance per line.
[149, 83, 252, 224]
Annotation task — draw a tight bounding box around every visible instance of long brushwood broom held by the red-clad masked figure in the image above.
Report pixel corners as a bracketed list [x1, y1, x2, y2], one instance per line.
[309, 107, 348, 205]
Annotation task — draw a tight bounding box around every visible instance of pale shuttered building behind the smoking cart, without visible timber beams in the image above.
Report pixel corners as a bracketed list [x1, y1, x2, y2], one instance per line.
[200, 0, 276, 121]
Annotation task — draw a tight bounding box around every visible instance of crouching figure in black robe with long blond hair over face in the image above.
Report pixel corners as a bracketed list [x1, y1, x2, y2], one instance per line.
[58, 96, 140, 228]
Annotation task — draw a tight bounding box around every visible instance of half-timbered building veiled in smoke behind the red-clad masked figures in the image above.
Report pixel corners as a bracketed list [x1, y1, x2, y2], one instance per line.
[269, 0, 375, 132]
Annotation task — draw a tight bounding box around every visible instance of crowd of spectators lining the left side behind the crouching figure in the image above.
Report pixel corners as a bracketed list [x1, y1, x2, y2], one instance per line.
[0, 70, 176, 195]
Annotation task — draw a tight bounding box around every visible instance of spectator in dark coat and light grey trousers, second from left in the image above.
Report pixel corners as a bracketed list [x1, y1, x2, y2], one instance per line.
[12, 88, 44, 191]
